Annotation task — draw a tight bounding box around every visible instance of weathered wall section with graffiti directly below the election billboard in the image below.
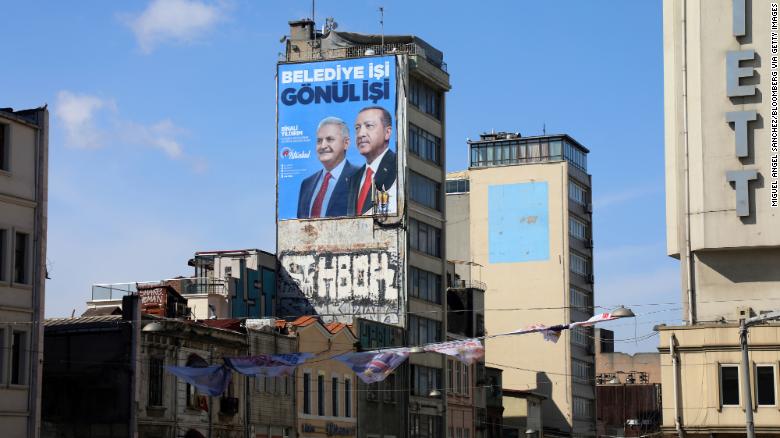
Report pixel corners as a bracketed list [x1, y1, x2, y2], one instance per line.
[279, 218, 404, 324]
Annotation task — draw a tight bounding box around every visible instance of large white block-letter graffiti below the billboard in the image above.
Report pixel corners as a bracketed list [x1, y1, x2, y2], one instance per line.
[279, 250, 402, 324]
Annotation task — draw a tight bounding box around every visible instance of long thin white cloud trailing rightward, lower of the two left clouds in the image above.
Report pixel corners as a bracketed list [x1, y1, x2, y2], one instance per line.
[54, 90, 197, 164]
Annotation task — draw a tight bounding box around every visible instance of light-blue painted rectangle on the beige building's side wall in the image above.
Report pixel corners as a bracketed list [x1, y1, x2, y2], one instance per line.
[488, 182, 550, 263]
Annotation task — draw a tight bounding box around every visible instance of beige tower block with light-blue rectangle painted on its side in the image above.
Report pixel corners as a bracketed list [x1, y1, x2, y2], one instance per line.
[446, 132, 595, 436]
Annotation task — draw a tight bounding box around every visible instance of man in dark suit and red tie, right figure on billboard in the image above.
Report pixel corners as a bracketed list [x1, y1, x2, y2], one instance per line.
[349, 106, 398, 216]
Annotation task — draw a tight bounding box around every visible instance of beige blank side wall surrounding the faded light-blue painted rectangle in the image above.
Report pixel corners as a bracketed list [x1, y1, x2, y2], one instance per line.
[447, 162, 580, 430]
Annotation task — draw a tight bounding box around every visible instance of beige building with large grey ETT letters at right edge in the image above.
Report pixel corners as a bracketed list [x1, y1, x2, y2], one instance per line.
[659, 0, 780, 436]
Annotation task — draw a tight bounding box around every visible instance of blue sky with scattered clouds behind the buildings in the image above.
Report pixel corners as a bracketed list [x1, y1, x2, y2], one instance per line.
[0, 0, 680, 352]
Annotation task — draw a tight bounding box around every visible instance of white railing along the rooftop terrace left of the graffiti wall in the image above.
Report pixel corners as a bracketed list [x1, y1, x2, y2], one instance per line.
[92, 277, 233, 301]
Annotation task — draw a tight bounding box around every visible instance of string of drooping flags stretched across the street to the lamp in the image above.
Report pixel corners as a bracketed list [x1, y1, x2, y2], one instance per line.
[165, 313, 618, 386]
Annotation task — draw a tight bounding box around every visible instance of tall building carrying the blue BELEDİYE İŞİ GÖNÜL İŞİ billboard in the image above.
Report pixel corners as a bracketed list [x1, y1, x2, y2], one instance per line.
[277, 20, 450, 437]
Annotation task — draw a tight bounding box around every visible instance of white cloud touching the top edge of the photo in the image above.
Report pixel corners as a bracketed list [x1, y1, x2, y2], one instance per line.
[126, 0, 224, 53]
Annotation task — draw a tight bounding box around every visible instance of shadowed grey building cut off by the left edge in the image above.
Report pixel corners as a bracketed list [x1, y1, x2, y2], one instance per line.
[0, 107, 49, 437]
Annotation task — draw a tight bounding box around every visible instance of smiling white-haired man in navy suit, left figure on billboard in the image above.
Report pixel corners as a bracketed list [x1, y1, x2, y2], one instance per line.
[298, 117, 358, 219]
